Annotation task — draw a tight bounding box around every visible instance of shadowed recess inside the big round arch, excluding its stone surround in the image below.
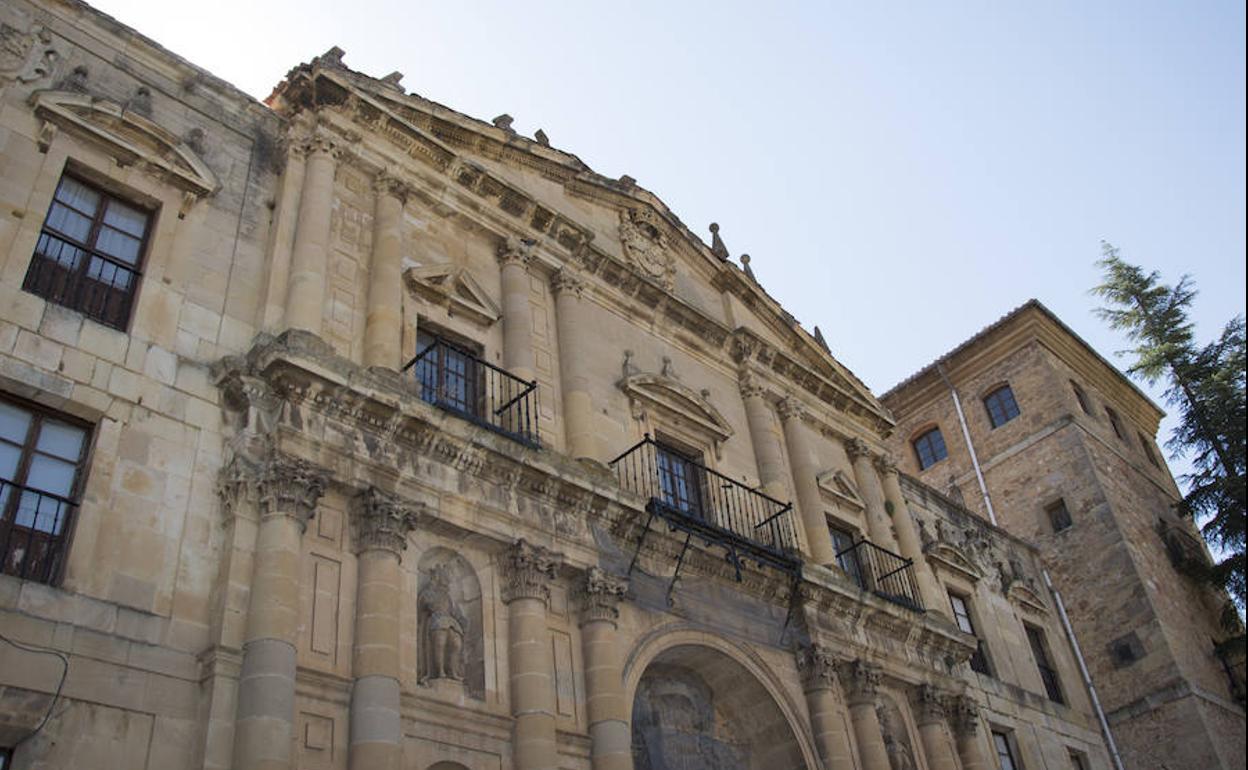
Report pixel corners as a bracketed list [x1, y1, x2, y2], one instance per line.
[633, 644, 806, 770]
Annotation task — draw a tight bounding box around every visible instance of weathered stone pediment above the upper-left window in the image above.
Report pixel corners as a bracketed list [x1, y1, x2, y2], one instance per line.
[31, 91, 220, 197]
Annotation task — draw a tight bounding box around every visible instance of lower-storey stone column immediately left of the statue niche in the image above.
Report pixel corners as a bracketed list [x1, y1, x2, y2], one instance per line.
[349, 488, 417, 770]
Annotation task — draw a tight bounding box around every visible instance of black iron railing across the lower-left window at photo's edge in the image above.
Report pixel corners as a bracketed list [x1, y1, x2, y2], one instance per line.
[0, 479, 77, 583]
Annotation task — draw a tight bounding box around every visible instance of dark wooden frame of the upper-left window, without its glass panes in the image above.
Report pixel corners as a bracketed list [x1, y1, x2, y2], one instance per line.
[22, 170, 156, 332]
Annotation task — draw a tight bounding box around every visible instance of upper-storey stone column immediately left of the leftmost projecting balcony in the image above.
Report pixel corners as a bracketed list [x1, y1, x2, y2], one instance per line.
[364, 171, 409, 369]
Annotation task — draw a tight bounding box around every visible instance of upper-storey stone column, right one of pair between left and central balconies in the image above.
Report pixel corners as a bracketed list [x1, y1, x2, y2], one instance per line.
[550, 270, 598, 459]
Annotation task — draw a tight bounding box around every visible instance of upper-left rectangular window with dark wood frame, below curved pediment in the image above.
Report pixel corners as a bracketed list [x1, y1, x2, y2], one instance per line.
[21, 176, 151, 331]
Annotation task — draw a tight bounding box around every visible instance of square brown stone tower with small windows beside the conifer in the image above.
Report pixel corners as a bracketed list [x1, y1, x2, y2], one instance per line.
[881, 301, 1244, 768]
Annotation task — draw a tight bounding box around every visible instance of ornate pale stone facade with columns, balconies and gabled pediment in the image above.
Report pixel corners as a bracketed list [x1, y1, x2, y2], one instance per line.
[0, 0, 1148, 770]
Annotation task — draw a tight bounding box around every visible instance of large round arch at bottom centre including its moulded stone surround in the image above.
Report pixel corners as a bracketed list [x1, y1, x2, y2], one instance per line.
[624, 628, 820, 770]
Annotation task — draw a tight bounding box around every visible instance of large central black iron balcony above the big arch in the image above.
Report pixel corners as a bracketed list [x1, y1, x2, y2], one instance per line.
[608, 436, 801, 578]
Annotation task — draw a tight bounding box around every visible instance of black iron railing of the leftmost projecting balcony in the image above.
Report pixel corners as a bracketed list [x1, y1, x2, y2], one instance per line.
[403, 339, 542, 447]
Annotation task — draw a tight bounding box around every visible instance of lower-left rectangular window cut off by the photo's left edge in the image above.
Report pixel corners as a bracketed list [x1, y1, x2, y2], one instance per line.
[0, 399, 90, 583]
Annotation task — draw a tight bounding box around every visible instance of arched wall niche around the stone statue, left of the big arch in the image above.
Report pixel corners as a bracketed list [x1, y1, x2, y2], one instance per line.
[417, 547, 485, 700]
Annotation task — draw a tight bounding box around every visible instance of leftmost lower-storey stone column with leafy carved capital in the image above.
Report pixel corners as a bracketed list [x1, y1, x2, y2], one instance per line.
[233, 458, 327, 770]
